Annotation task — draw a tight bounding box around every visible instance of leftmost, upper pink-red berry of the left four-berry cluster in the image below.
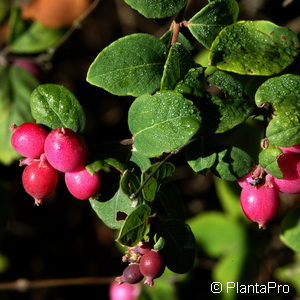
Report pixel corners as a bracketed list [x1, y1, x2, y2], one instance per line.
[11, 123, 48, 158]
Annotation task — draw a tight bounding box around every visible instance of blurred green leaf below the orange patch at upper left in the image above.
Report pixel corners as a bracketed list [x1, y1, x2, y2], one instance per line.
[9, 22, 65, 54]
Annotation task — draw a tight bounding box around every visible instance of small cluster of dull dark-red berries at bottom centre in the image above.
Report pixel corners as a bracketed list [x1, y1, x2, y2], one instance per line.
[116, 242, 166, 286]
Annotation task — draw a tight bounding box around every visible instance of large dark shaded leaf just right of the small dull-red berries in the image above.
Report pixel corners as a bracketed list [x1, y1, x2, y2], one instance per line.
[158, 220, 195, 274]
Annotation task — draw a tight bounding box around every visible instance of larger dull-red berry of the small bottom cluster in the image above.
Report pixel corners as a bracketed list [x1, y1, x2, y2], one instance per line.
[140, 250, 165, 286]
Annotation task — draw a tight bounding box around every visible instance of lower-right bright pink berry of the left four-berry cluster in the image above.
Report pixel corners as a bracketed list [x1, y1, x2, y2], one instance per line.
[65, 167, 101, 200]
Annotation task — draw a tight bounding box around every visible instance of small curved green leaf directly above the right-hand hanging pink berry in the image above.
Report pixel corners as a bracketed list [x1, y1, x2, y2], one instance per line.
[258, 146, 283, 178]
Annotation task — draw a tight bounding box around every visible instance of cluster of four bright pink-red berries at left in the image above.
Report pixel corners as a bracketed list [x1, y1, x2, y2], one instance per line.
[11, 123, 100, 205]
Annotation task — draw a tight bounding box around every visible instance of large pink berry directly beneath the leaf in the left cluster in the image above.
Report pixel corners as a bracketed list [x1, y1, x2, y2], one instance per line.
[44, 128, 87, 172]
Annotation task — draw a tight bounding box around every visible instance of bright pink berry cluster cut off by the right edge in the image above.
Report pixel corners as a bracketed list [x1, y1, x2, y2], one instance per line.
[238, 145, 300, 228]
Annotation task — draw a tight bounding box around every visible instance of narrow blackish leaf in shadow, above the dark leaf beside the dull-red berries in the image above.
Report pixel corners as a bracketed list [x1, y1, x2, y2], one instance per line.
[158, 183, 185, 221]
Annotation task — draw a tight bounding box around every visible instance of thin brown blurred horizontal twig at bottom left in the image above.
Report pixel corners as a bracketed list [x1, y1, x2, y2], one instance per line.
[0, 277, 115, 292]
